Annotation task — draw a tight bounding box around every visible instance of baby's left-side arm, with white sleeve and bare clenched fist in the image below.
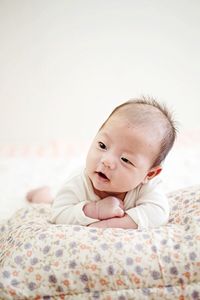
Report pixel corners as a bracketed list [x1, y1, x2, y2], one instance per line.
[50, 179, 124, 226]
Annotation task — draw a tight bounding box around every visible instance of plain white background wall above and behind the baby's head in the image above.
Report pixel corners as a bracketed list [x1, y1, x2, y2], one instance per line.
[0, 0, 200, 143]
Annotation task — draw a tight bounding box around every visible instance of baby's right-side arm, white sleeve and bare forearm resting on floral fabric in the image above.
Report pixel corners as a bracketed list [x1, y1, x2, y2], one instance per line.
[89, 179, 170, 229]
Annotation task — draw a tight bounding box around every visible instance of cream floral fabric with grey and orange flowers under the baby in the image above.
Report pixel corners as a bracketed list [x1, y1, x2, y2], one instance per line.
[0, 186, 200, 300]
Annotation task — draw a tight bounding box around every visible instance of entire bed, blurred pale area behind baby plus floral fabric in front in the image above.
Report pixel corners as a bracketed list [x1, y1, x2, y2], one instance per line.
[0, 133, 200, 300]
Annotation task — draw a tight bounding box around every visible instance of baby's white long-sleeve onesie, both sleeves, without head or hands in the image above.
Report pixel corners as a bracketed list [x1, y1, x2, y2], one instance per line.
[51, 169, 169, 229]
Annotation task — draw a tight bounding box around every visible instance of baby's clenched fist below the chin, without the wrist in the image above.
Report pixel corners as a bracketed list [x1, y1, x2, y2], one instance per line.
[96, 196, 124, 220]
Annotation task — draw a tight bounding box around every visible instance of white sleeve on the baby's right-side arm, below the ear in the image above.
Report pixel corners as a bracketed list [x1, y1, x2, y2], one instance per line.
[126, 179, 170, 229]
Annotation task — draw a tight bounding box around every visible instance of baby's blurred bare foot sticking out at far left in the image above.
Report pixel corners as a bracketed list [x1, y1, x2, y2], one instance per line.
[26, 186, 53, 203]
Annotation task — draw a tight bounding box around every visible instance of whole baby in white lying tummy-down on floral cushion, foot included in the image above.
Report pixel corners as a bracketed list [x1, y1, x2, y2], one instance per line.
[27, 98, 176, 229]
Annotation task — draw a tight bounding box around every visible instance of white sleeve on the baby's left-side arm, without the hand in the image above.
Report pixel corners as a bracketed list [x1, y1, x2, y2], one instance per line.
[50, 180, 99, 226]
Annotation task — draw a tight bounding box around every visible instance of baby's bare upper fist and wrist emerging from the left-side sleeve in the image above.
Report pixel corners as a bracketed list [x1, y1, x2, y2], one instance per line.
[83, 196, 124, 220]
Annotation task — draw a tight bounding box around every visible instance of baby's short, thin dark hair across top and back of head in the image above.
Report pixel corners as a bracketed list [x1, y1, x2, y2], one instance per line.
[100, 96, 178, 167]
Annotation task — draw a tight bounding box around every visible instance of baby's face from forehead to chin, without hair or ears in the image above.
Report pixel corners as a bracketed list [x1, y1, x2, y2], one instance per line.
[86, 116, 159, 197]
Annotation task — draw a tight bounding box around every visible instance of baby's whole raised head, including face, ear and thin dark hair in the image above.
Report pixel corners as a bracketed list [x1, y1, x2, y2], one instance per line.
[86, 98, 176, 197]
